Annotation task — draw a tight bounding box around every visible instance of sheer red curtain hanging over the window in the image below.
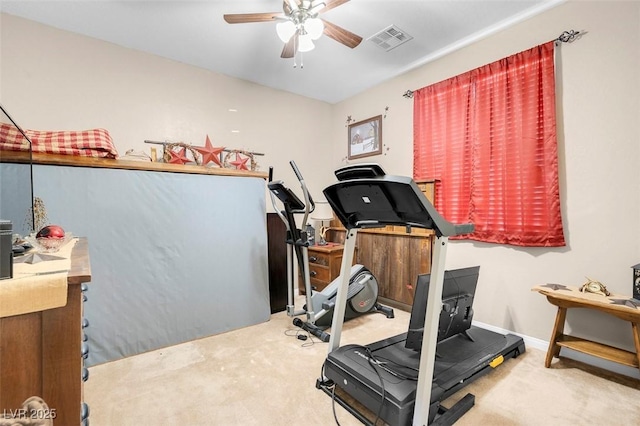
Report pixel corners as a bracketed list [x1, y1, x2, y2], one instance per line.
[413, 42, 565, 246]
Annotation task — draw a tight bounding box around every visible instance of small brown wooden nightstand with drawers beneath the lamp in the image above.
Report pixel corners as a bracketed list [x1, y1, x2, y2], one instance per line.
[298, 243, 344, 294]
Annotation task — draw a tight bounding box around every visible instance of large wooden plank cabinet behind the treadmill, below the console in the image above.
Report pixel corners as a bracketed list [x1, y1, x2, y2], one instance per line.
[328, 181, 435, 310]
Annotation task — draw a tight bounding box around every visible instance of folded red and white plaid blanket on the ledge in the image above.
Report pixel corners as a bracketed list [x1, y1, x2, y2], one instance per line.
[0, 123, 118, 158]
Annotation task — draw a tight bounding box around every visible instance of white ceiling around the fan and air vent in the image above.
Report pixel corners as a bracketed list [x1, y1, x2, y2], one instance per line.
[0, 0, 563, 103]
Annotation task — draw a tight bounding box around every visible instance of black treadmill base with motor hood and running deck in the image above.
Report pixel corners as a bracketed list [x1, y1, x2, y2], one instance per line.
[325, 326, 525, 425]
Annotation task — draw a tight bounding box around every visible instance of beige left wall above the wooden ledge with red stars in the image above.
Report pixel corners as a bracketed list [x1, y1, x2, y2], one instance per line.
[0, 14, 331, 200]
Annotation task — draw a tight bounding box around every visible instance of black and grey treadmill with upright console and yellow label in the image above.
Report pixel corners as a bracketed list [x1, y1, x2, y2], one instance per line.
[316, 164, 525, 425]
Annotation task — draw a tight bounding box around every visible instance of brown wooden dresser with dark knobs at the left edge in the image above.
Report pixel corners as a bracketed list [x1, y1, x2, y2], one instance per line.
[0, 238, 91, 426]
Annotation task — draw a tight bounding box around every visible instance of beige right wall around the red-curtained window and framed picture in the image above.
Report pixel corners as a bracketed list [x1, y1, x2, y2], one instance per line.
[331, 1, 640, 347]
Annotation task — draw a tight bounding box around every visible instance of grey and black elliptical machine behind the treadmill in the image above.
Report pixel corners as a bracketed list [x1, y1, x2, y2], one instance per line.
[267, 161, 394, 342]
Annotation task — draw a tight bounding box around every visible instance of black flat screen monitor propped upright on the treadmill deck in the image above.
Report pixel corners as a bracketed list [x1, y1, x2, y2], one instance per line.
[405, 266, 480, 351]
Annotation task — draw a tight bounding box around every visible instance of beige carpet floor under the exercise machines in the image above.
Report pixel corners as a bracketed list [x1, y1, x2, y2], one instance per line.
[84, 302, 640, 426]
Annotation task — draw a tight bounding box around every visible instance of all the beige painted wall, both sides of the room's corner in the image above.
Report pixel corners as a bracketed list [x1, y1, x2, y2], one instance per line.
[0, 1, 640, 360]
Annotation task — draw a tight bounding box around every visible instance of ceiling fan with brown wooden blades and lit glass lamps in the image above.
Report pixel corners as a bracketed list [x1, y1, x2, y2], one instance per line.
[224, 0, 362, 58]
